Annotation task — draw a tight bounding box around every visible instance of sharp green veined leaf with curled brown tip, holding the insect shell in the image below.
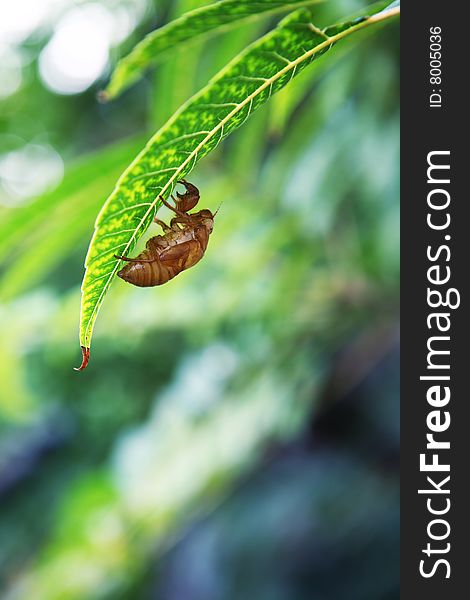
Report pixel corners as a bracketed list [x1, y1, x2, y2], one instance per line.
[80, 2, 399, 368]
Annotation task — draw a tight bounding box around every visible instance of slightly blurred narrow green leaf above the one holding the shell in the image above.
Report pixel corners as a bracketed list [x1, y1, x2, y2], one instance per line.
[100, 0, 322, 100]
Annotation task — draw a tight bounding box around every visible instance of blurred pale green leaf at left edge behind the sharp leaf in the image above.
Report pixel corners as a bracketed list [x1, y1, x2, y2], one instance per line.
[0, 136, 145, 300]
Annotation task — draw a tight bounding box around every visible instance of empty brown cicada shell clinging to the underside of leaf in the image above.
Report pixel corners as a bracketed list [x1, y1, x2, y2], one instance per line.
[116, 179, 215, 287]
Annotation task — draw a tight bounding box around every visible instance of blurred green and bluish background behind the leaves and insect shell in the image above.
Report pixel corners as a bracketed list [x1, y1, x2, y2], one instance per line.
[0, 0, 399, 600]
